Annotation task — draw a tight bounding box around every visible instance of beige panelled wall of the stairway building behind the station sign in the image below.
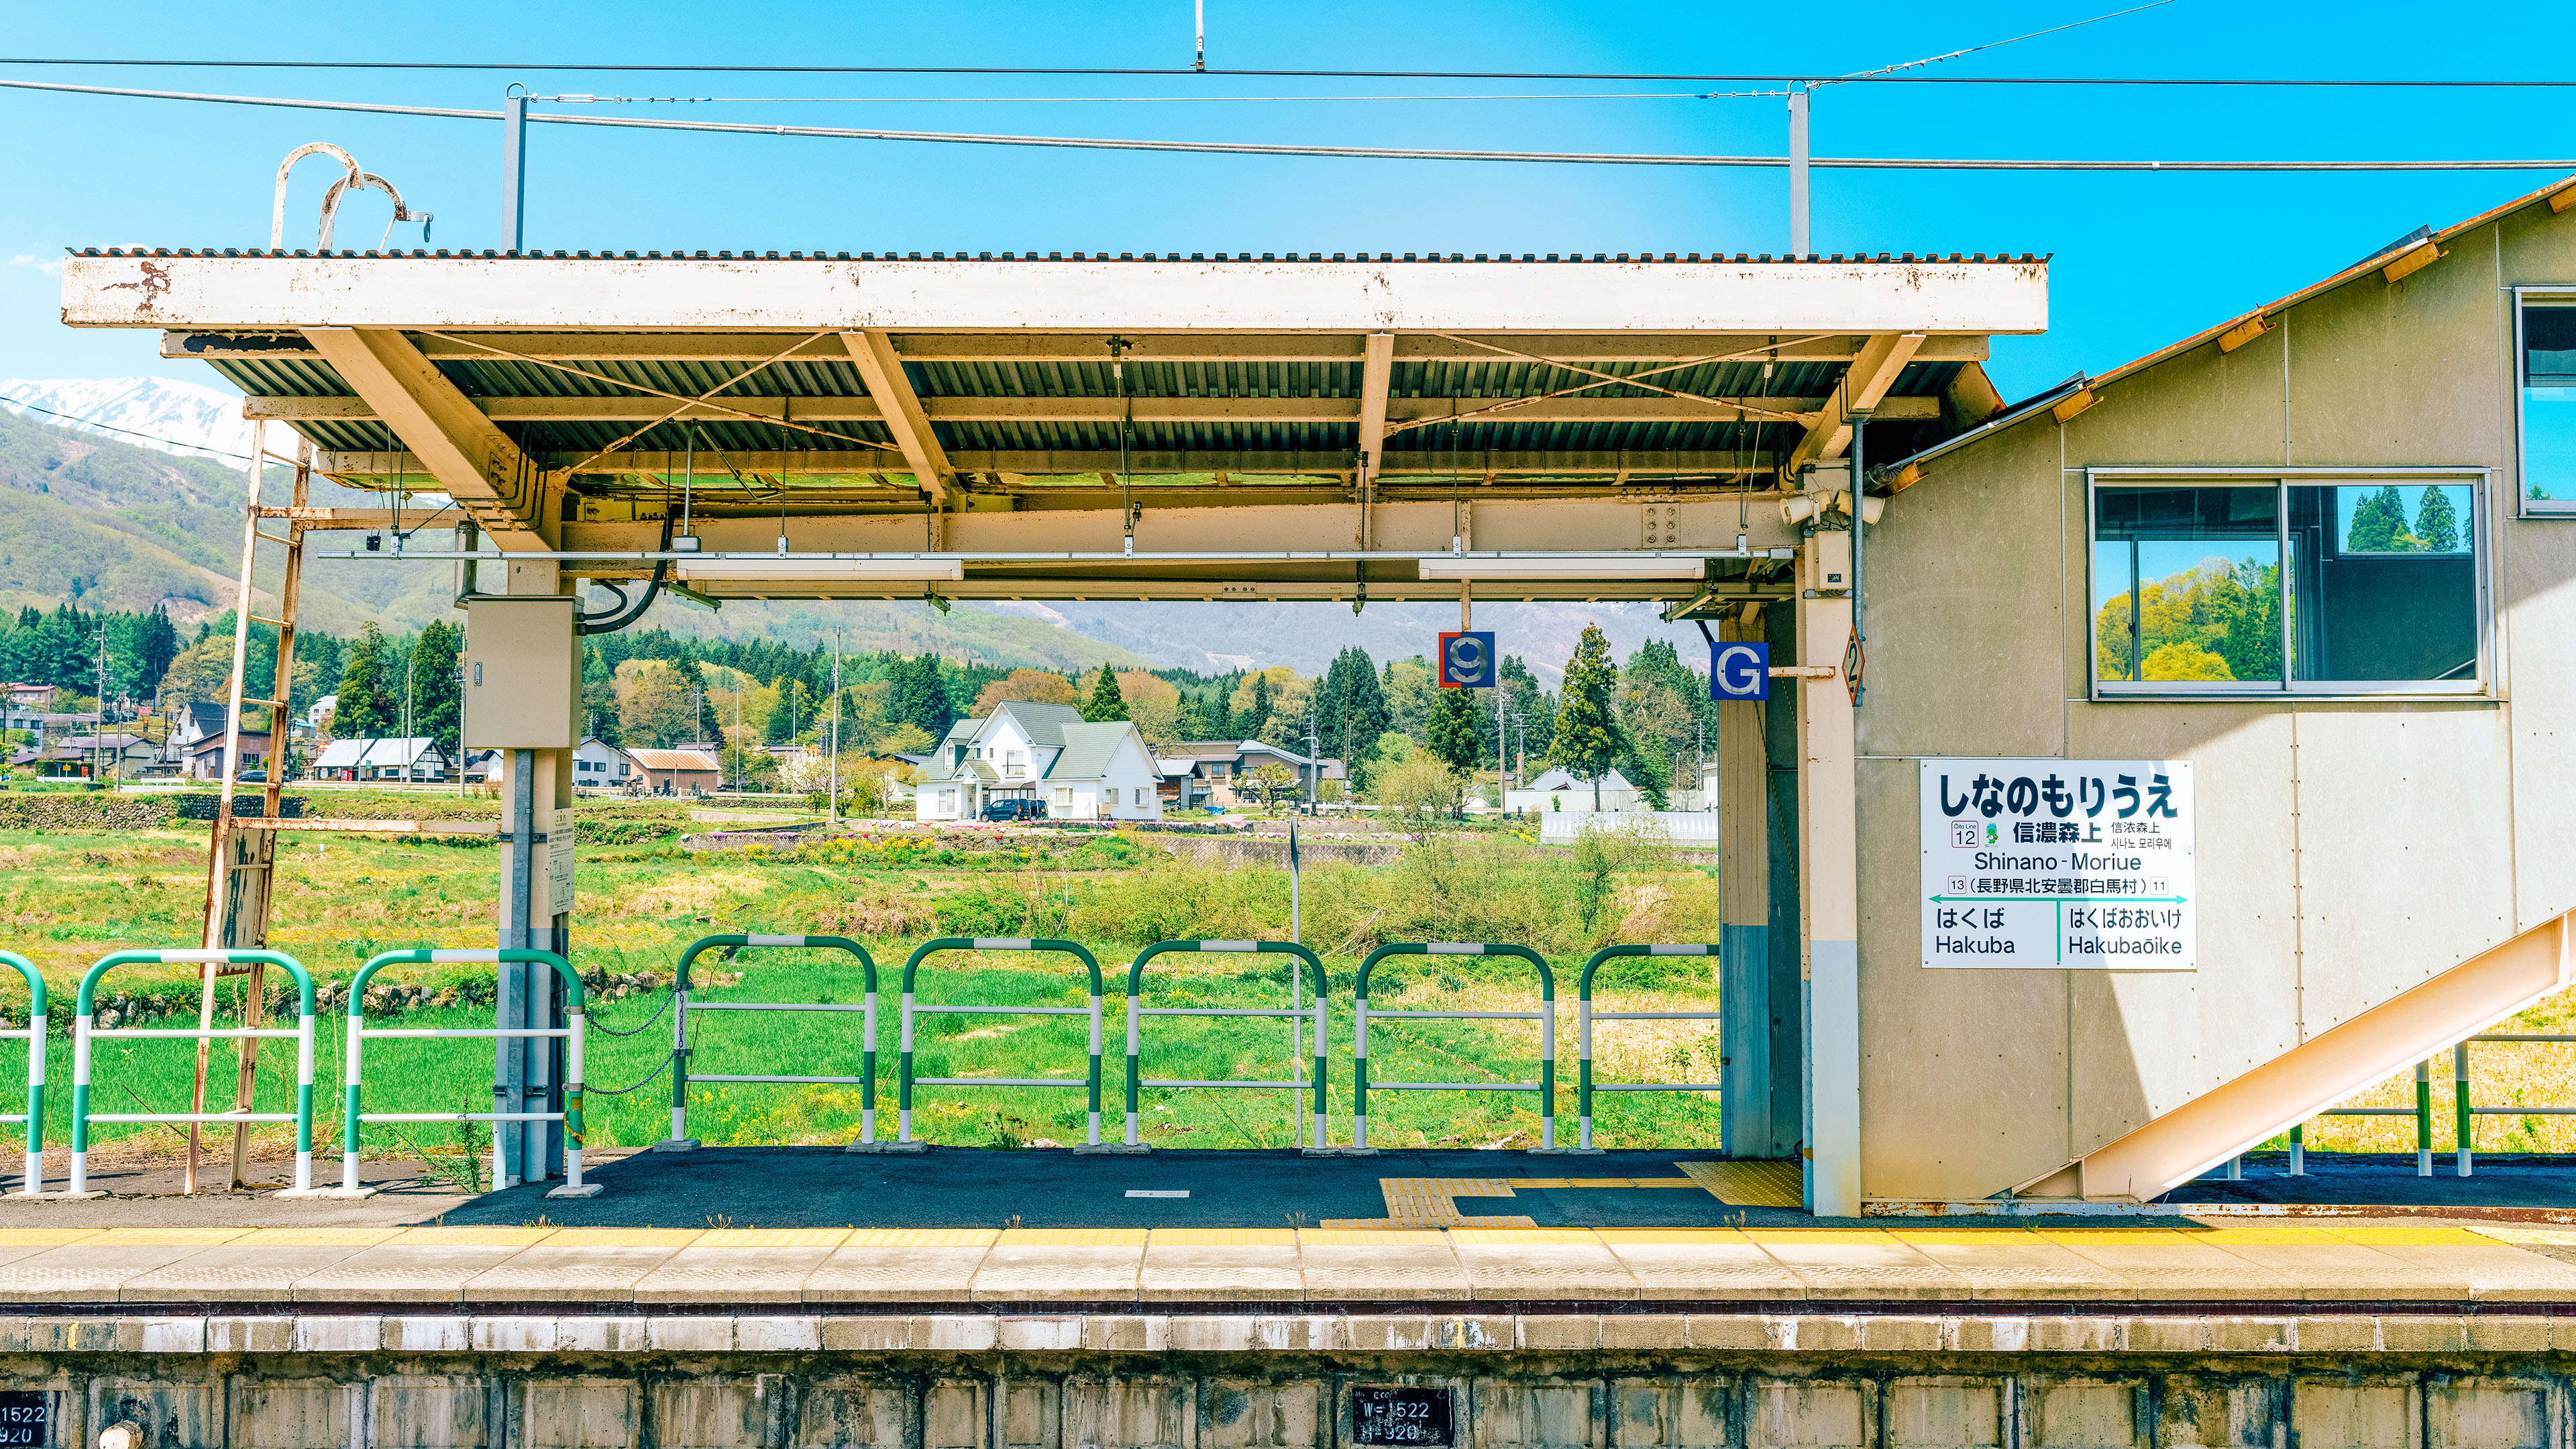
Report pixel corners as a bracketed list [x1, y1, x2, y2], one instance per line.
[1860, 189, 2576, 1199]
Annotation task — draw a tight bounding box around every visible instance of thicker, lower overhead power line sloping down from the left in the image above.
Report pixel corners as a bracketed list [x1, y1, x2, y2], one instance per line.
[15, 80, 2576, 173]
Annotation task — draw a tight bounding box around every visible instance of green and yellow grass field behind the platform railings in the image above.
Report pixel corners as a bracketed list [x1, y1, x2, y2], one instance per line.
[0, 814, 1718, 1161]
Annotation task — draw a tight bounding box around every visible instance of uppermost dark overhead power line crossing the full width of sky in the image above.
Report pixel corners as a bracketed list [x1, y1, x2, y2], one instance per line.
[0, 57, 2576, 91]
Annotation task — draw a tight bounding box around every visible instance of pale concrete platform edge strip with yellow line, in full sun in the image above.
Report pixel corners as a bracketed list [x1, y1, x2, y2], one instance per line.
[0, 1220, 2576, 1315]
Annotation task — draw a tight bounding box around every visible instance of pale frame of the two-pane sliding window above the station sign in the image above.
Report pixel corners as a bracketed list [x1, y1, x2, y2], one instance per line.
[2084, 464, 2493, 704]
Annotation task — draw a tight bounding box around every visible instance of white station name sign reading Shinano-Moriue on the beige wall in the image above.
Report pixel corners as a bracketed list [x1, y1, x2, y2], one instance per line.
[1922, 758, 2195, 972]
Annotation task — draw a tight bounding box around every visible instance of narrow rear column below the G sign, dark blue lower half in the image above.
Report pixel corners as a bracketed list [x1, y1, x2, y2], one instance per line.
[1715, 603, 1780, 1158]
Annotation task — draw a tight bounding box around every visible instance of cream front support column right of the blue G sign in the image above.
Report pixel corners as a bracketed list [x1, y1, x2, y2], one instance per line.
[1798, 513, 1860, 1217]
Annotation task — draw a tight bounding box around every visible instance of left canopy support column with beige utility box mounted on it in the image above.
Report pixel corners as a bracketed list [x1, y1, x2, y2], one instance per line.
[464, 559, 582, 1186]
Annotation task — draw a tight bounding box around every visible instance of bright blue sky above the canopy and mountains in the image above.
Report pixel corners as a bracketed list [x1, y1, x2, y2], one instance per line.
[0, 0, 2576, 397]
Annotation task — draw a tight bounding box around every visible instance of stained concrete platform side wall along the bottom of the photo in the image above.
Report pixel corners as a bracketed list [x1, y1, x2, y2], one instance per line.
[15, 1312, 2568, 1449]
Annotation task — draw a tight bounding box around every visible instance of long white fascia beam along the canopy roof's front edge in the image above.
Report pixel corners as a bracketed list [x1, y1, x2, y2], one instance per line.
[62, 255, 2048, 337]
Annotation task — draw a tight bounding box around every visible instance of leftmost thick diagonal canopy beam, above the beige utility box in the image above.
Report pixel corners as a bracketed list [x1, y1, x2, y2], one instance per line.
[304, 327, 564, 551]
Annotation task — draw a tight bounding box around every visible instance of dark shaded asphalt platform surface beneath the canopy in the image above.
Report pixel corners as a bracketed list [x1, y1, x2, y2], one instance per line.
[443, 1147, 1741, 1227]
